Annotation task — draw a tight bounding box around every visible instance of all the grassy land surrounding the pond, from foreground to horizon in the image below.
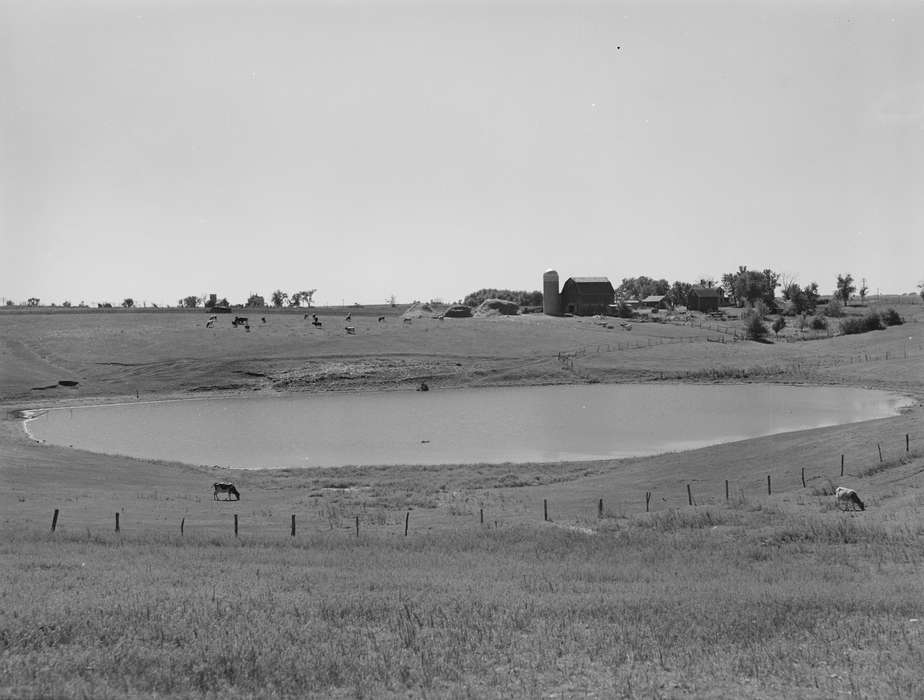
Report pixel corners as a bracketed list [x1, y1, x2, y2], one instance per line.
[0, 305, 924, 698]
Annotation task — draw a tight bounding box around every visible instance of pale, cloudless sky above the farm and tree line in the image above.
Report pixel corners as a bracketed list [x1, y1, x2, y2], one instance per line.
[0, 0, 924, 304]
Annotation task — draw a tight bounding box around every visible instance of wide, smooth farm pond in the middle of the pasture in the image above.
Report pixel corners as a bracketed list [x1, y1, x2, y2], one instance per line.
[25, 384, 911, 469]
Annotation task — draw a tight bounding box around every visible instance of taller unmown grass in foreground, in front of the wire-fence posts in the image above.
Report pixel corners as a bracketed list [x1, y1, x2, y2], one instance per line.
[0, 505, 924, 697]
